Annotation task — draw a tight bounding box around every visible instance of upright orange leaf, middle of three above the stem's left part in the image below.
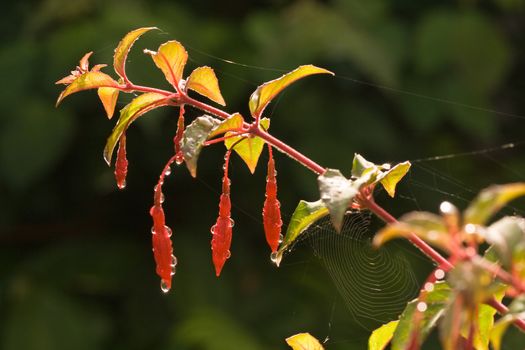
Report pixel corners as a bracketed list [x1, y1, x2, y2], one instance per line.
[144, 40, 188, 89]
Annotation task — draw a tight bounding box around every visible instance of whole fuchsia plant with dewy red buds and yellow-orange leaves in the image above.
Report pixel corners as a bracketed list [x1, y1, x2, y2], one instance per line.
[57, 27, 525, 350]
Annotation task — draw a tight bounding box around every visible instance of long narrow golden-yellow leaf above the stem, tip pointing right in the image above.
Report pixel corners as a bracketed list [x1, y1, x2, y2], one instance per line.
[248, 65, 334, 117]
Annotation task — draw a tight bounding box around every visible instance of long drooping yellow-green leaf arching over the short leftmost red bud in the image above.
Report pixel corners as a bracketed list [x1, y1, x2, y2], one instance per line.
[104, 92, 167, 165]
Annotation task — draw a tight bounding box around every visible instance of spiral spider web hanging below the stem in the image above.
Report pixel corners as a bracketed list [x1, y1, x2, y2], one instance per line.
[284, 212, 418, 329]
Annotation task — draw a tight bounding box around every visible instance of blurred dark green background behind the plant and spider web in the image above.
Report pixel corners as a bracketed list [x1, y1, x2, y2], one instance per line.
[0, 0, 525, 350]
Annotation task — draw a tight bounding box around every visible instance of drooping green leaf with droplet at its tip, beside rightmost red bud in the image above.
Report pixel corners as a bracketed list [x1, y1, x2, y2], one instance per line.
[273, 199, 329, 266]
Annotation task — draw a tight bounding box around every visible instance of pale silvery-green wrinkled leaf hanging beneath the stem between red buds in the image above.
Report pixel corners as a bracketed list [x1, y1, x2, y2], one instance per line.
[181, 114, 221, 177]
